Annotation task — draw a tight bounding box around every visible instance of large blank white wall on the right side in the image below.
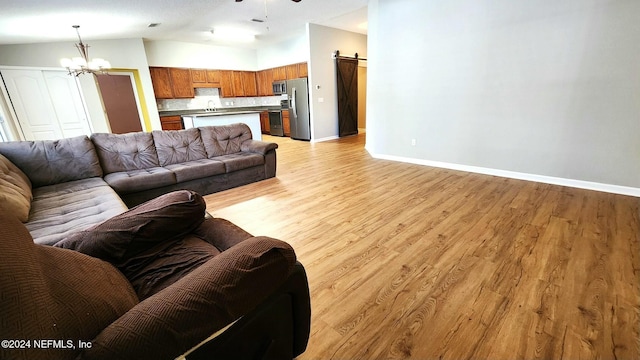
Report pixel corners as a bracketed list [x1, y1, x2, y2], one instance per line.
[367, 0, 640, 194]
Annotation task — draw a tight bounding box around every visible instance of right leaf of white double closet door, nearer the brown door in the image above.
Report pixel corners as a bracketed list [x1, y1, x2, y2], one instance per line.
[42, 71, 91, 138]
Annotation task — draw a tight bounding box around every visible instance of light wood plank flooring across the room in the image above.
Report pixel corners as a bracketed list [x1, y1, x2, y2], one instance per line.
[205, 135, 640, 360]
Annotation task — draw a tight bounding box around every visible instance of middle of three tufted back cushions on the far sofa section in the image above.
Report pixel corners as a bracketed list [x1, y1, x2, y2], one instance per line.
[151, 128, 207, 166]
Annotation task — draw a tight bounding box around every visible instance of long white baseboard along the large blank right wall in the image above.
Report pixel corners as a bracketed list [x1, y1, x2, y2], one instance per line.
[365, 147, 640, 197]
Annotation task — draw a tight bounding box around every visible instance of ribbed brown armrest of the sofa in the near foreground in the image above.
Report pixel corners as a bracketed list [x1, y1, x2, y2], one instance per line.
[80, 237, 296, 359]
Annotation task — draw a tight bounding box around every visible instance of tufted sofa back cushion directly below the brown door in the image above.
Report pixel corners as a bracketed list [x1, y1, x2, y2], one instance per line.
[91, 132, 159, 174]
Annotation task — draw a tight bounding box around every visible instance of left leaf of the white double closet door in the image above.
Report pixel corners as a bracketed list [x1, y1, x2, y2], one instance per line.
[1, 70, 63, 140]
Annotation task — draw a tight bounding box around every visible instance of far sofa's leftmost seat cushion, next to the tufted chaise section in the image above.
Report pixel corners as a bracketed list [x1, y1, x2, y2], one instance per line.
[104, 167, 176, 194]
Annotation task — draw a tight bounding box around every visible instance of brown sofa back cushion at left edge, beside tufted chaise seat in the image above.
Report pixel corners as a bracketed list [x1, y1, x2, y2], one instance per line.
[0, 155, 33, 222]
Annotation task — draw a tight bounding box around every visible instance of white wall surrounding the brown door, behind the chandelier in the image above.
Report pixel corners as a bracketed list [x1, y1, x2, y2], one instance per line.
[0, 39, 160, 132]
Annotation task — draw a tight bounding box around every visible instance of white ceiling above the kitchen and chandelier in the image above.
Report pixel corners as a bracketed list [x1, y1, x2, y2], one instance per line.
[0, 0, 368, 48]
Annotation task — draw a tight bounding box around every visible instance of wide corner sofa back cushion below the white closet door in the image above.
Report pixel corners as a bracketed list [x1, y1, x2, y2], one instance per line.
[0, 135, 102, 187]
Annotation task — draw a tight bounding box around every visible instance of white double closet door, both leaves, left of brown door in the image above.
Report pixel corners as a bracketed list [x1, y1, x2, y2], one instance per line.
[0, 69, 91, 140]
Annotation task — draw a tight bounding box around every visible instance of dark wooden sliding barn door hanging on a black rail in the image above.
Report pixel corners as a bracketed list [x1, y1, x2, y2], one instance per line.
[336, 57, 358, 136]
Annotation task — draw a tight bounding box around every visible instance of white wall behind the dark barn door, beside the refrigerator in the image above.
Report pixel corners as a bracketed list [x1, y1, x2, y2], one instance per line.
[307, 24, 367, 141]
